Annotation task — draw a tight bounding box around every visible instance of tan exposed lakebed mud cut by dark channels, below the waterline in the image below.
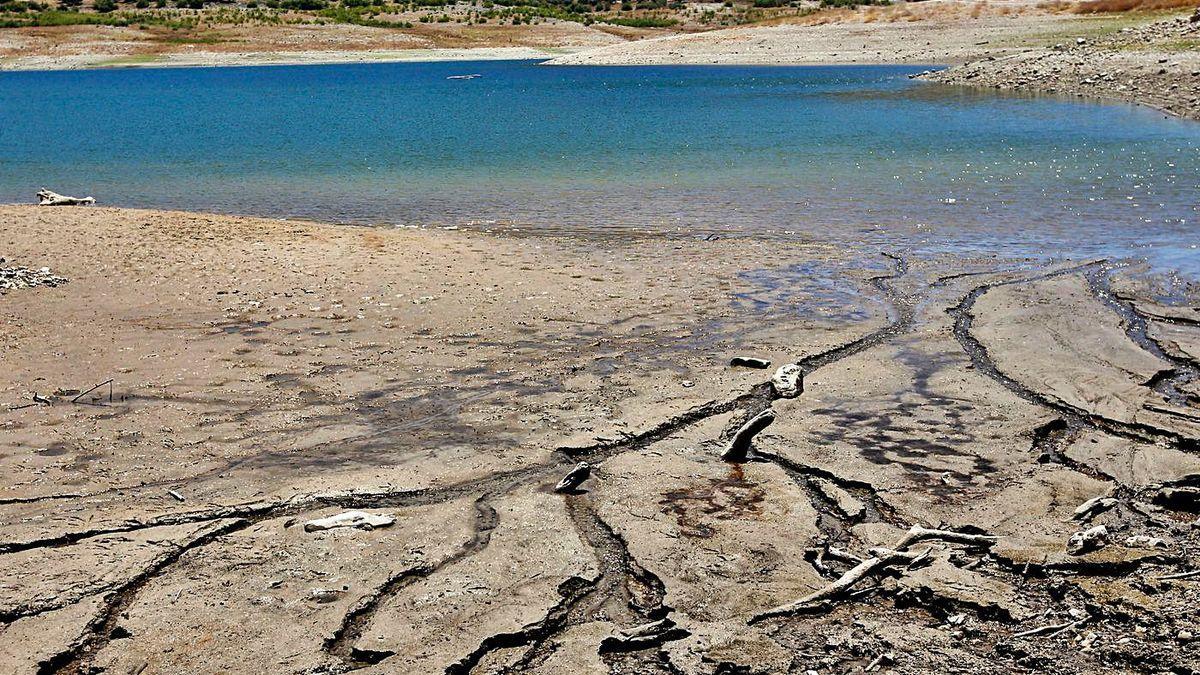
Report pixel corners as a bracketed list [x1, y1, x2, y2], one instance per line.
[0, 207, 1200, 674]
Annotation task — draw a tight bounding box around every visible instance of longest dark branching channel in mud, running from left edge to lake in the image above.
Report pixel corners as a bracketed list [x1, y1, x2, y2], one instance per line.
[14, 248, 914, 674]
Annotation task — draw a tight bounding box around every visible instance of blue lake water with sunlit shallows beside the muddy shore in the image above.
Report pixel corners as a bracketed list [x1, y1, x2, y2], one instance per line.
[0, 61, 1200, 267]
